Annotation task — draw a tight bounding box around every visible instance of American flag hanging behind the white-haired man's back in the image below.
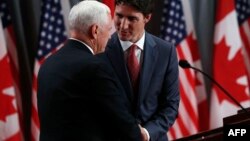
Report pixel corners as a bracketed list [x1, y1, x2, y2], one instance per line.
[31, 0, 67, 141]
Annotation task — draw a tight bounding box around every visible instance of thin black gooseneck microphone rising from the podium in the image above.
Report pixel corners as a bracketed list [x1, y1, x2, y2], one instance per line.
[179, 60, 248, 113]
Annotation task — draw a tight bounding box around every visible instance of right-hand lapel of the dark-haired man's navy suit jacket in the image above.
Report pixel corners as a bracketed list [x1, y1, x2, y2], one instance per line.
[139, 32, 158, 104]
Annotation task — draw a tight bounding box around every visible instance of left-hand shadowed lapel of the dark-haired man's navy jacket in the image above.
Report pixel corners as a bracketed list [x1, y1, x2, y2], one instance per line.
[106, 34, 133, 101]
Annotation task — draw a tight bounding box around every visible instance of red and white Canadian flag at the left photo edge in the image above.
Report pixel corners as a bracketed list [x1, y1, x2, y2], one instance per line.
[0, 11, 22, 141]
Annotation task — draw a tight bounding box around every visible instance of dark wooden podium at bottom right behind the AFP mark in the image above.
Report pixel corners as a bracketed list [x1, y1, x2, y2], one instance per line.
[175, 108, 250, 141]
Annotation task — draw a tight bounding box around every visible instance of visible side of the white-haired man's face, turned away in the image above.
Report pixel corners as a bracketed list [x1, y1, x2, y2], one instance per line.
[96, 15, 112, 53]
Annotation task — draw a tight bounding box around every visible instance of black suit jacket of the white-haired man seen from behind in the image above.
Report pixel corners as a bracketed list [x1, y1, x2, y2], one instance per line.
[38, 40, 141, 141]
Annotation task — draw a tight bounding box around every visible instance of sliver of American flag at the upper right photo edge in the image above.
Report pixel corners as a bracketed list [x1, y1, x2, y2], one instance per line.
[235, 0, 250, 90]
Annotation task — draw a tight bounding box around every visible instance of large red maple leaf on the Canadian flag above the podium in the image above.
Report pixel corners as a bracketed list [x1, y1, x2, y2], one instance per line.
[213, 38, 249, 104]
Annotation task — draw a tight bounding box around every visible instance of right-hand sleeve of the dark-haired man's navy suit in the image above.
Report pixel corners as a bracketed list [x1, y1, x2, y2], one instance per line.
[144, 43, 180, 141]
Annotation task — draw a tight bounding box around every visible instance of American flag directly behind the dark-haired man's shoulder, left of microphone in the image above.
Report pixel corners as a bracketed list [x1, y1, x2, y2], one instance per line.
[161, 0, 209, 140]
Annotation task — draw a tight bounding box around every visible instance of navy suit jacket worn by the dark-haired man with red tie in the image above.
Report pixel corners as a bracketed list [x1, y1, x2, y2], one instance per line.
[106, 32, 180, 141]
